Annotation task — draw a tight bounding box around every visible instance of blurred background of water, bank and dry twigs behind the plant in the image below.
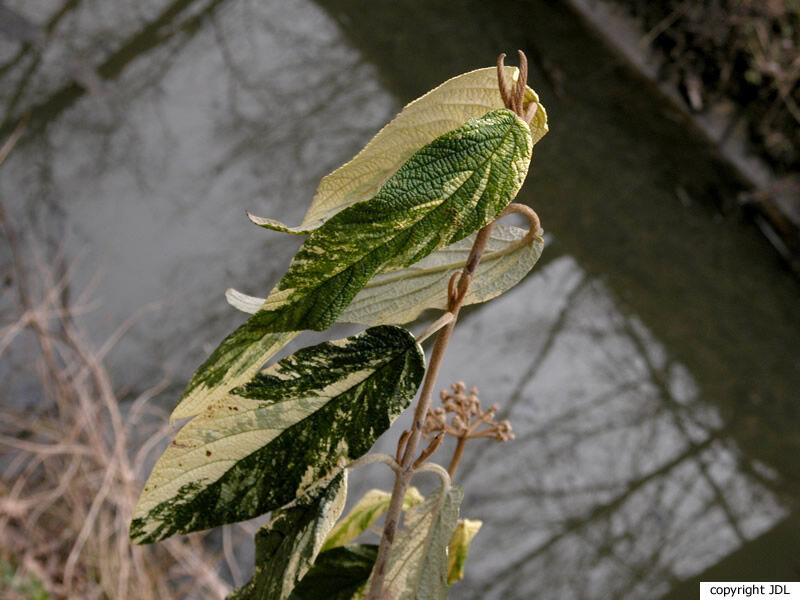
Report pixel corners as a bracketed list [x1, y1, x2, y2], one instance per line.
[0, 0, 800, 600]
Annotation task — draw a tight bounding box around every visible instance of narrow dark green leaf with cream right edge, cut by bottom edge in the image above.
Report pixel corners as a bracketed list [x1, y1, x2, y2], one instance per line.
[228, 471, 347, 600]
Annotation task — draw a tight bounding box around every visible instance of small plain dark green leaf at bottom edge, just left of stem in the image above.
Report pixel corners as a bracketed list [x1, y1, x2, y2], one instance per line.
[289, 544, 378, 600]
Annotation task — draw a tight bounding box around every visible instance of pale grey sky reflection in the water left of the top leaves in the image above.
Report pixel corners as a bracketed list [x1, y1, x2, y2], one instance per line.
[0, 1, 396, 385]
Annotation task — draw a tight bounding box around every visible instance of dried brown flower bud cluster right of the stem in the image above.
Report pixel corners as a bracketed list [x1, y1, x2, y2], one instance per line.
[423, 381, 514, 442]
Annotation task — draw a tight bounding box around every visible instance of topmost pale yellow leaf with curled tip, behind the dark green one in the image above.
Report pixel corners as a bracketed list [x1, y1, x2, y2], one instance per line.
[250, 67, 547, 234]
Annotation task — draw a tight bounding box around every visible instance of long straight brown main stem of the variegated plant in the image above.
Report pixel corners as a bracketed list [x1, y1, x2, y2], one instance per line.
[367, 222, 494, 600]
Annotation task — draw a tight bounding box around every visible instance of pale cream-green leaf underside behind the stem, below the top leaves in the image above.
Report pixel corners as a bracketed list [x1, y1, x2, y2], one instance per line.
[225, 225, 543, 325]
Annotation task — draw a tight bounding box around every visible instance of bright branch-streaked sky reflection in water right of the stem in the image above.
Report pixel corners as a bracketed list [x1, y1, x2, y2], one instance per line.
[422, 257, 786, 599]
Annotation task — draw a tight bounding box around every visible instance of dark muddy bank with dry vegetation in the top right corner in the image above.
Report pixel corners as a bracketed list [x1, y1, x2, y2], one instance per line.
[569, 0, 800, 274]
